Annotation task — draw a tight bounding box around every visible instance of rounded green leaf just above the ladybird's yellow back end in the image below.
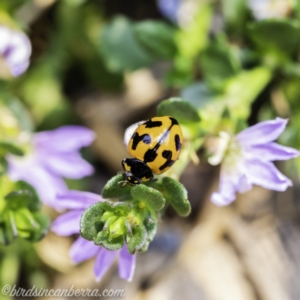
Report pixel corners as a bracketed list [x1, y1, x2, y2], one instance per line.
[157, 98, 200, 124]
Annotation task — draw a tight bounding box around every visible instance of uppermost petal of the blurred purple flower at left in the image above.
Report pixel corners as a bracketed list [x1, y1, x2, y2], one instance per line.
[34, 126, 95, 153]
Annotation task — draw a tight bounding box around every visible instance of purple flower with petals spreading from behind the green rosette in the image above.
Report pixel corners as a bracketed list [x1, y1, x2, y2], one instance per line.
[52, 191, 135, 281]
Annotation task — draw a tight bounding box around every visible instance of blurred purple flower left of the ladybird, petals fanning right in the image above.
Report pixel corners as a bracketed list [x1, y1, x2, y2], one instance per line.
[7, 126, 95, 208]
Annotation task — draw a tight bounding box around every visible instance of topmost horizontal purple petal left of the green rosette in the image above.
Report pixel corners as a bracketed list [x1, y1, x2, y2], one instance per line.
[57, 191, 103, 209]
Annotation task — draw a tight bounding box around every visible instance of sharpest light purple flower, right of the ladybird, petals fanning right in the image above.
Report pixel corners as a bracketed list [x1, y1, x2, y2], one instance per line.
[210, 118, 300, 205]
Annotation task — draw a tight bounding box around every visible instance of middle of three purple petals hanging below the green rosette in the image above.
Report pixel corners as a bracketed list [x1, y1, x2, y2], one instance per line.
[94, 248, 118, 281]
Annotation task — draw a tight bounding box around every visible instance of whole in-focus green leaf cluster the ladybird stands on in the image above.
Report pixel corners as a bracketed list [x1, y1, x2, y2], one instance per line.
[80, 174, 190, 254]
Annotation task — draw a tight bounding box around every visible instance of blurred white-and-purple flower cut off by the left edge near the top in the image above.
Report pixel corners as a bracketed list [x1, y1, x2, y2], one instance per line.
[0, 26, 31, 77]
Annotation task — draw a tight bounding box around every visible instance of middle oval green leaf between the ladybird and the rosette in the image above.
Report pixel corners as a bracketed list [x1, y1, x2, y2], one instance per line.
[130, 184, 166, 210]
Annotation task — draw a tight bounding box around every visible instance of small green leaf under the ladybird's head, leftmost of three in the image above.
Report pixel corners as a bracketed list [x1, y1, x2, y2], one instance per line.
[101, 174, 131, 198]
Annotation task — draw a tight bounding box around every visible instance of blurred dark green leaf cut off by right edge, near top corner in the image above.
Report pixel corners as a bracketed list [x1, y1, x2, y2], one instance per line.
[249, 19, 300, 56]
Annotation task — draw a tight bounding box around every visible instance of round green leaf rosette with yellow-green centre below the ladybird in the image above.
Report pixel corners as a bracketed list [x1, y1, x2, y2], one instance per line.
[80, 198, 152, 254]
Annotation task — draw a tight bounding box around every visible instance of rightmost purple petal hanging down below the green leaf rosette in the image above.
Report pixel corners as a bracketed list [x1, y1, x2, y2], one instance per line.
[118, 245, 136, 281]
